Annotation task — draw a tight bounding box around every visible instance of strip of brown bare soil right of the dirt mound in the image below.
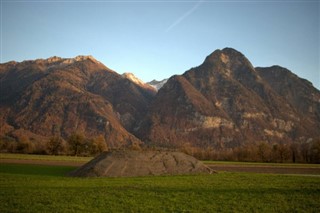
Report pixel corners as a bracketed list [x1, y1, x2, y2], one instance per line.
[206, 164, 320, 175]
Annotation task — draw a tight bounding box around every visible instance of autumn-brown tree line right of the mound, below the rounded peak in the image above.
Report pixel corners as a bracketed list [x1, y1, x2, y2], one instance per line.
[180, 139, 320, 163]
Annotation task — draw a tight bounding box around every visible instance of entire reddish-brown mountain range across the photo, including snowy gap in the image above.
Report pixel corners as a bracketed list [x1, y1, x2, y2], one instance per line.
[0, 48, 320, 153]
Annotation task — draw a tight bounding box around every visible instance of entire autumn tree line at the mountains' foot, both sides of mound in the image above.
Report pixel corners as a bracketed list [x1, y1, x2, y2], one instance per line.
[0, 133, 320, 163]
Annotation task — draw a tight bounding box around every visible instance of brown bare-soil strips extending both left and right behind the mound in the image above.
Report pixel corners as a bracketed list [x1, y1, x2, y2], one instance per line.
[0, 159, 320, 176]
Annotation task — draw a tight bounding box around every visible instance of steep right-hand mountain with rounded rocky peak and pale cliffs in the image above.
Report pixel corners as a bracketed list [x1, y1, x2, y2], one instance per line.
[135, 48, 320, 149]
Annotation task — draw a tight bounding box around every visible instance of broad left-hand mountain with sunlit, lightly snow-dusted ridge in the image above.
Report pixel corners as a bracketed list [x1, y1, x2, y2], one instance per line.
[0, 56, 155, 147]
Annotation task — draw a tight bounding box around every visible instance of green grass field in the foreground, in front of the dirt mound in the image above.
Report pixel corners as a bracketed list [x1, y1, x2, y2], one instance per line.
[0, 164, 320, 212]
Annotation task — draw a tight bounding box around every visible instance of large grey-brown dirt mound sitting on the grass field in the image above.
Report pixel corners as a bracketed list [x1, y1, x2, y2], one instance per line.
[71, 151, 212, 177]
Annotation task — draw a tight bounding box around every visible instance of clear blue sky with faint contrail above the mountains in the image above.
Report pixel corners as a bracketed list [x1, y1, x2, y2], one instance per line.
[0, 0, 320, 89]
